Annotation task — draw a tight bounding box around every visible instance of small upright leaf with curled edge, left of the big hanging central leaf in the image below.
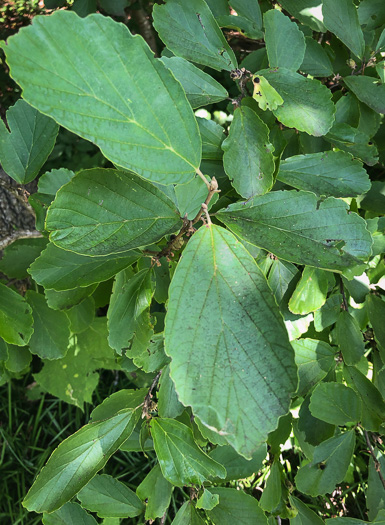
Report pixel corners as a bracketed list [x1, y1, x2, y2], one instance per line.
[107, 268, 154, 355]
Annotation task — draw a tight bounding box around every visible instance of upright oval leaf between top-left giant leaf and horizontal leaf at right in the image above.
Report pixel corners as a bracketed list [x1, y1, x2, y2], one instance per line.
[222, 106, 275, 199]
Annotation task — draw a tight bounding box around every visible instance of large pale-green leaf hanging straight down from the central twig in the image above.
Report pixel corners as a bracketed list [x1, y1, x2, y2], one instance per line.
[165, 225, 297, 458]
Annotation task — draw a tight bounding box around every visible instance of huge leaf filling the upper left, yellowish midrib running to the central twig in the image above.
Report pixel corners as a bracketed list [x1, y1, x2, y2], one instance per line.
[4, 10, 201, 184]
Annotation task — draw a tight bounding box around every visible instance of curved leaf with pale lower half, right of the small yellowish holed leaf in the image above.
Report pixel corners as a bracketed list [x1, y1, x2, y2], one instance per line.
[258, 67, 335, 137]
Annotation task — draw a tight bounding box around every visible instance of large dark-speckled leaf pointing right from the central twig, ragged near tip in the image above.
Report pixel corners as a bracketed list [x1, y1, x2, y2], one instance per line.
[217, 191, 372, 273]
